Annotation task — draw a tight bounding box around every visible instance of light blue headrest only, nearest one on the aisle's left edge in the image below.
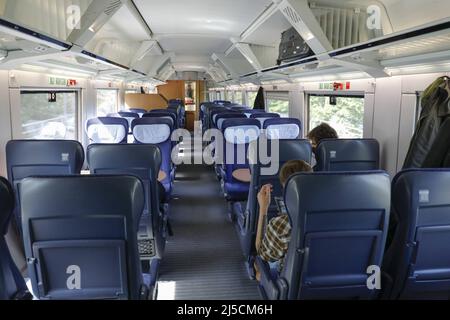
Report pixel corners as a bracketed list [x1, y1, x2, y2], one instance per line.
[132, 117, 173, 144]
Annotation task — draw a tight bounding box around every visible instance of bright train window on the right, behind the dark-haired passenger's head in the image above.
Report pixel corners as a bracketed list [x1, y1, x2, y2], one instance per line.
[308, 95, 364, 139]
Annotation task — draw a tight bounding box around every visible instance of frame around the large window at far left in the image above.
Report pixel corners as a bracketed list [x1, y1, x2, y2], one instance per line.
[18, 88, 83, 141]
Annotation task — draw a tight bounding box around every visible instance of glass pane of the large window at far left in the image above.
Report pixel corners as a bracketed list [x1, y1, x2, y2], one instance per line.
[20, 91, 78, 140]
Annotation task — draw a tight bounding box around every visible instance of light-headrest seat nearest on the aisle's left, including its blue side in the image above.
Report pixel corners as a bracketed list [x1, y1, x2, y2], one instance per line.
[132, 117, 174, 202]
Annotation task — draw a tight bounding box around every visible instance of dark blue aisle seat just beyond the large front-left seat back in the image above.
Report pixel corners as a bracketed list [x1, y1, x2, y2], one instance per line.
[87, 144, 165, 259]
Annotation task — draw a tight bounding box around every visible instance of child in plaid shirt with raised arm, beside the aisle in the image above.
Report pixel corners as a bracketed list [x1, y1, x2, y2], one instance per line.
[255, 160, 313, 280]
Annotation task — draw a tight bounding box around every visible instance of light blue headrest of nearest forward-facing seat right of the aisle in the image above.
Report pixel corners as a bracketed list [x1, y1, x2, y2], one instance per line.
[222, 118, 261, 144]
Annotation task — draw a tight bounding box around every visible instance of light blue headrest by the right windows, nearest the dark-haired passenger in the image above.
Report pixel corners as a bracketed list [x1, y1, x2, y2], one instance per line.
[263, 118, 302, 140]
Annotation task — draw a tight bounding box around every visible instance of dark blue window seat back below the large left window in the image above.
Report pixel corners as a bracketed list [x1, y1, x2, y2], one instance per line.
[6, 140, 84, 228]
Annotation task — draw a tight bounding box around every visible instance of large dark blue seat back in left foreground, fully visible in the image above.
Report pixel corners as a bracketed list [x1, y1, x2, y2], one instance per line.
[21, 176, 145, 300]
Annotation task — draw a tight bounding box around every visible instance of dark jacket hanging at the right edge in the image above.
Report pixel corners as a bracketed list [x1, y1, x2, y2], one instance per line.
[403, 77, 450, 169]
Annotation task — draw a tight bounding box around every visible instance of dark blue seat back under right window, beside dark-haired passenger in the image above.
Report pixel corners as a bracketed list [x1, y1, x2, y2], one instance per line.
[316, 139, 380, 171]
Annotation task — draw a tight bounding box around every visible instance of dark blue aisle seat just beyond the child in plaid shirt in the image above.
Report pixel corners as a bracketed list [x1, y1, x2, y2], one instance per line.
[241, 139, 312, 257]
